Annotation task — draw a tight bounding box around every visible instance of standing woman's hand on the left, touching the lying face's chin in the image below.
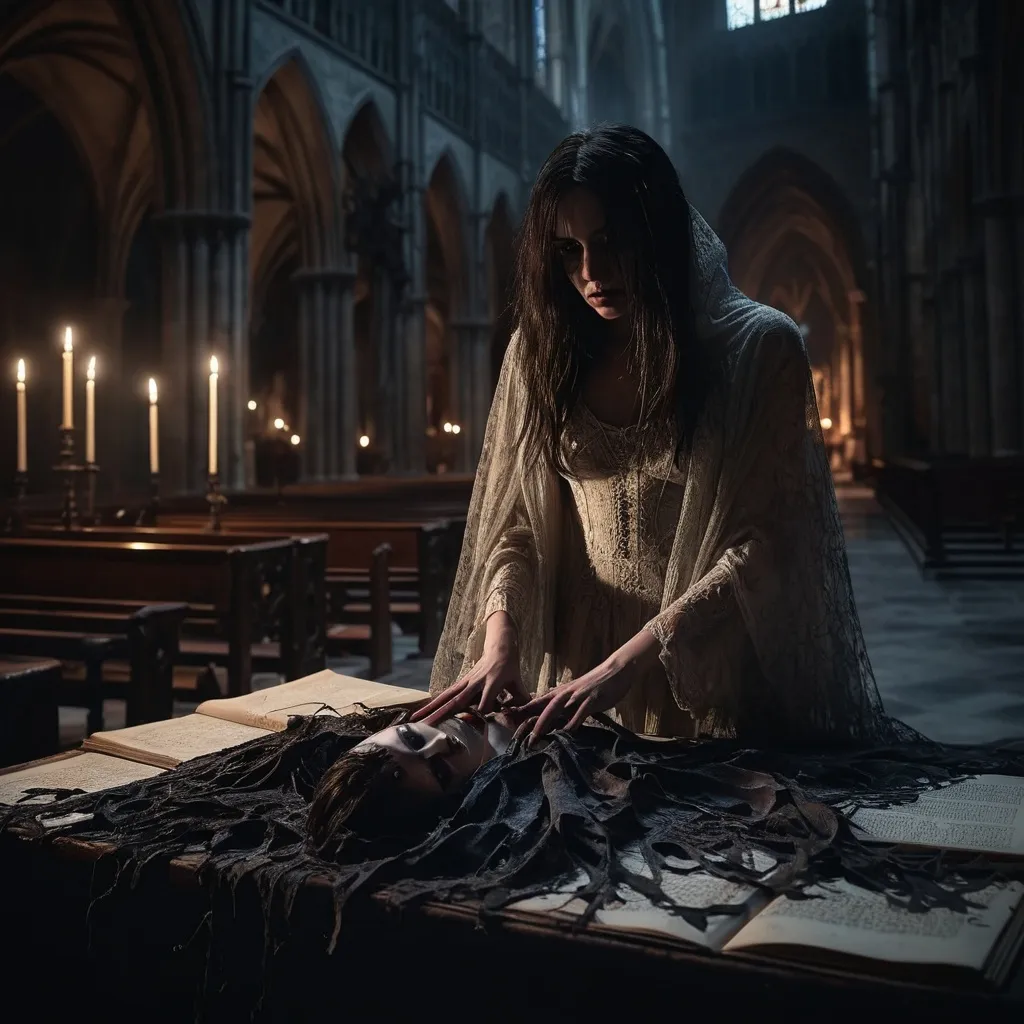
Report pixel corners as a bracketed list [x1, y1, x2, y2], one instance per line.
[412, 611, 529, 725]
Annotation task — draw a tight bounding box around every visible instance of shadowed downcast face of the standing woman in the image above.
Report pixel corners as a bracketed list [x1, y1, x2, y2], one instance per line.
[555, 187, 627, 321]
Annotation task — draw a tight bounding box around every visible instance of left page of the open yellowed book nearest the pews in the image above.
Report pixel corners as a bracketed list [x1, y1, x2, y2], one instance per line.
[82, 715, 268, 768]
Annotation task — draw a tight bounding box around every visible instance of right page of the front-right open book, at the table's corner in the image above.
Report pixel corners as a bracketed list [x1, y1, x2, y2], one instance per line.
[725, 882, 1024, 972]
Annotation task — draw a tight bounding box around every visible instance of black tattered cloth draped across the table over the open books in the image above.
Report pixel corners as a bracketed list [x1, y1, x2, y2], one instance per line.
[0, 712, 1024, 999]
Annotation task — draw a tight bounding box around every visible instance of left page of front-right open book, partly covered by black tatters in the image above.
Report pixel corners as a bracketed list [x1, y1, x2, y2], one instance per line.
[509, 858, 765, 949]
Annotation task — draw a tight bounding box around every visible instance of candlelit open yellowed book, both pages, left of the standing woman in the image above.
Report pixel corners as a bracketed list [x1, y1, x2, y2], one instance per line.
[82, 670, 429, 768]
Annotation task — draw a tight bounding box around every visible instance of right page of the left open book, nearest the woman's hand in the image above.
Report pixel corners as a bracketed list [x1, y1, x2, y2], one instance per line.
[196, 669, 430, 732]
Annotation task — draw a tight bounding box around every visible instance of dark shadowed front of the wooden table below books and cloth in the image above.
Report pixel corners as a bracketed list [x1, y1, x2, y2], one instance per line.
[0, 790, 1024, 1024]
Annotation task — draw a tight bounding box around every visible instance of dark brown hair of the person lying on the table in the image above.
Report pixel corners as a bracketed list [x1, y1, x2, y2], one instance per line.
[307, 746, 456, 858]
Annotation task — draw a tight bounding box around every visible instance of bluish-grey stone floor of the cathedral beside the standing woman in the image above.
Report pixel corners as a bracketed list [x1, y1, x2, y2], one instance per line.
[60, 485, 1024, 745]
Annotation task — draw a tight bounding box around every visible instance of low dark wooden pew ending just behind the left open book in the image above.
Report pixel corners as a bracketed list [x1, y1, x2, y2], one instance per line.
[0, 595, 187, 732]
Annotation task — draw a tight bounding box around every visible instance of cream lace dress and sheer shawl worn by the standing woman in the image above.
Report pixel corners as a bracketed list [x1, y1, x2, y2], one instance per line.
[430, 210, 902, 742]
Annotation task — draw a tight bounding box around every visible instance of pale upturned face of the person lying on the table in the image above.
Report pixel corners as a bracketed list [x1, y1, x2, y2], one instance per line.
[354, 713, 496, 798]
